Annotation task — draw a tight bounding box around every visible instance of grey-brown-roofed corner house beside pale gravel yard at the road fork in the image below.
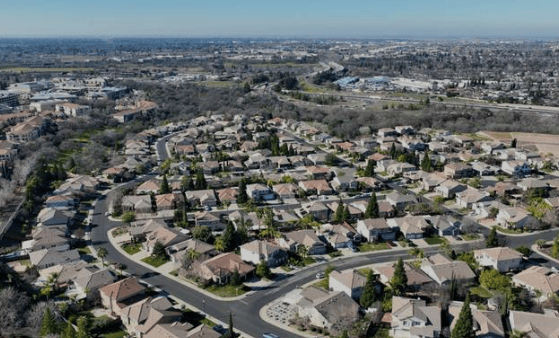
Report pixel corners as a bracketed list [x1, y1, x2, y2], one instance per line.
[297, 286, 359, 332]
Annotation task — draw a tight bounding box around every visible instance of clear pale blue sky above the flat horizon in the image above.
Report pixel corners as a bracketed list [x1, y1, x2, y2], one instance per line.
[0, 0, 559, 38]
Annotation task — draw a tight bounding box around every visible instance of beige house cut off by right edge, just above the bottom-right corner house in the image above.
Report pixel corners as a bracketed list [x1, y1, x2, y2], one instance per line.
[512, 266, 559, 299]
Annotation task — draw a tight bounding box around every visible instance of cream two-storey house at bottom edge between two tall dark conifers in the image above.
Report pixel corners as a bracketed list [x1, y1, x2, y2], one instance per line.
[390, 296, 442, 338]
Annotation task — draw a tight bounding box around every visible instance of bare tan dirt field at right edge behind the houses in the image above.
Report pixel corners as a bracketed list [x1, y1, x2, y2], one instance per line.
[480, 131, 559, 157]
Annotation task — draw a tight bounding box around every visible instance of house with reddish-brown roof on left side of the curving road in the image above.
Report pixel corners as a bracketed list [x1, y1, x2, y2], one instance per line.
[99, 277, 146, 316]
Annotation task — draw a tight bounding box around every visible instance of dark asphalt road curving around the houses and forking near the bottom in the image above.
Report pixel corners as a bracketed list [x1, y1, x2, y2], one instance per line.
[90, 135, 559, 338]
